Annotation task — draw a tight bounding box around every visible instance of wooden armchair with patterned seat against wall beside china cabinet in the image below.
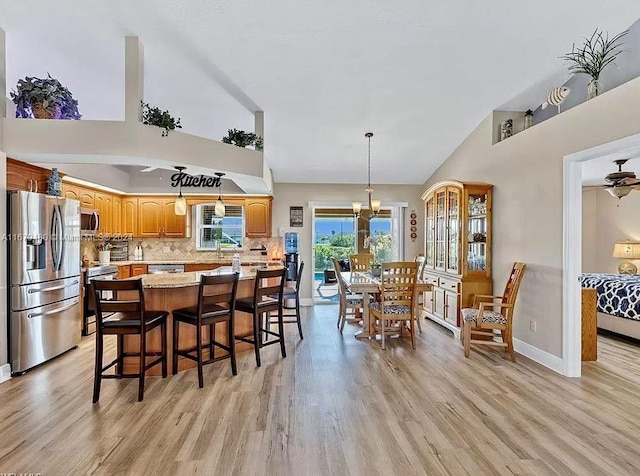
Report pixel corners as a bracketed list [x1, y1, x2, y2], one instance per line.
[462, 262, 527, 362]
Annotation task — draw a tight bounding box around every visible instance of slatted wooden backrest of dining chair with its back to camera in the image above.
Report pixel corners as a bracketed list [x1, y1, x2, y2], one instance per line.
[380, 261, 418, 313]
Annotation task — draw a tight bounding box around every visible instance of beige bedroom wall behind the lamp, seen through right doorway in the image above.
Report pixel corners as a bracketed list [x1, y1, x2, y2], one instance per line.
[582, 189, 640, 273]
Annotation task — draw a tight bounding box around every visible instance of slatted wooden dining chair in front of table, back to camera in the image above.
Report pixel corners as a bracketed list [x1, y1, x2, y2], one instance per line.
[369, 261, 418, 349]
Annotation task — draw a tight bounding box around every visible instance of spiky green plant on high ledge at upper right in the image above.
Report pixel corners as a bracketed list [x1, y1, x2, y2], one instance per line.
[560, 28, 629, 99]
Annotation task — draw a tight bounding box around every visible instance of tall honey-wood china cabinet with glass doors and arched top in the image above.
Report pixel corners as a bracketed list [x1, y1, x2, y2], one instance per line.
[422, 181, 493, 337]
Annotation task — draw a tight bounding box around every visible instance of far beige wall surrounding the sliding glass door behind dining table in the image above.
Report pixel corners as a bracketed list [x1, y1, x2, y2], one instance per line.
[273, 183, 424, 298]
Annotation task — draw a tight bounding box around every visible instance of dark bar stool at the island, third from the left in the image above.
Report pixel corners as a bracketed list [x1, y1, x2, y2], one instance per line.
[236, 268, 287, 367]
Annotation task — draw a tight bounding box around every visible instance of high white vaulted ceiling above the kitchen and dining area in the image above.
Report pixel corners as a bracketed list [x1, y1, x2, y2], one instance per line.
[0, 0, 640, 184]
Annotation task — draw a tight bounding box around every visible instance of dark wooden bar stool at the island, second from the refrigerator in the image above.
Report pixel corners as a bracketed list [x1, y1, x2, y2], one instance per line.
[172, 273, 238, 388]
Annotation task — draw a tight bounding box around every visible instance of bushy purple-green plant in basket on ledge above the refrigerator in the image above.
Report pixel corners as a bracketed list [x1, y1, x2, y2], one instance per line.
[10, 73, 82, 119]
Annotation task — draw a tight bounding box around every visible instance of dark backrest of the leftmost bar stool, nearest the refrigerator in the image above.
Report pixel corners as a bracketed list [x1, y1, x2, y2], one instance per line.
[91, 278, 144, 328]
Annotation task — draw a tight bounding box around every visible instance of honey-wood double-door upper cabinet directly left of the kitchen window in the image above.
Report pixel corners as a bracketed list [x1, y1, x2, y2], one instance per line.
[138, 197, 186, 238]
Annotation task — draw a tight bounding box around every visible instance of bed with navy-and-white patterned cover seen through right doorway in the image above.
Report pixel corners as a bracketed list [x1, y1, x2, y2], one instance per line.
[580, 273, 640, 339]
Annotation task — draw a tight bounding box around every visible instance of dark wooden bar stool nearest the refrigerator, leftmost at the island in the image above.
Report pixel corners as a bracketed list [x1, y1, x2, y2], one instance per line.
[92, 279, 169, 403]
